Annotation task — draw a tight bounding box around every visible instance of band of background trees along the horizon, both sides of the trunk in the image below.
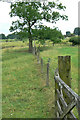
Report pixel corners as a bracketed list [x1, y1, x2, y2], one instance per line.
[0, 25, 80, 40]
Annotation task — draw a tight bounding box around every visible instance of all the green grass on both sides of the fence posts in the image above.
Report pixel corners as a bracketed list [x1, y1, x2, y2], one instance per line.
[2, 40, 78, 118]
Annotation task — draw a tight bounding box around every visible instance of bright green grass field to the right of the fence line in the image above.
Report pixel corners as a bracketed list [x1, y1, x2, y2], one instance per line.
[41, 45, 78, 93]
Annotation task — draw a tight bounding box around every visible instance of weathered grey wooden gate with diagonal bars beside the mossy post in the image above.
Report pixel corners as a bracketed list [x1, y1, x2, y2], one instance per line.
[54, 72, 80, 119]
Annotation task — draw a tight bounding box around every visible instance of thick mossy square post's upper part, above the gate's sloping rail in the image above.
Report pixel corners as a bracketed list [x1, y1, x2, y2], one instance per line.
[58, 56, 71, 87]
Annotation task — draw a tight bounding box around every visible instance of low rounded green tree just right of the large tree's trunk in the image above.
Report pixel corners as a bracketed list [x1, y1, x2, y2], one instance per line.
[33, 25, 64, 44]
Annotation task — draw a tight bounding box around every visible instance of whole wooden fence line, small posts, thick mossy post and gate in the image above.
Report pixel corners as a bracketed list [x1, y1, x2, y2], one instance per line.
[34, 46, 80, 120]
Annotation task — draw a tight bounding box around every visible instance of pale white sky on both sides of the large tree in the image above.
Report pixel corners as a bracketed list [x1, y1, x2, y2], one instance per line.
[0, 0, 80, 35]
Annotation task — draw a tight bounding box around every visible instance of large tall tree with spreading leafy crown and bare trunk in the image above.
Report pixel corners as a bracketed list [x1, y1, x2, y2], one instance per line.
[10, 1, 67, 52]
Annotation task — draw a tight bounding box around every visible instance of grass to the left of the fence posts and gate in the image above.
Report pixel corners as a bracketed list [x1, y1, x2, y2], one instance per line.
[2, 48, 54, 118]
